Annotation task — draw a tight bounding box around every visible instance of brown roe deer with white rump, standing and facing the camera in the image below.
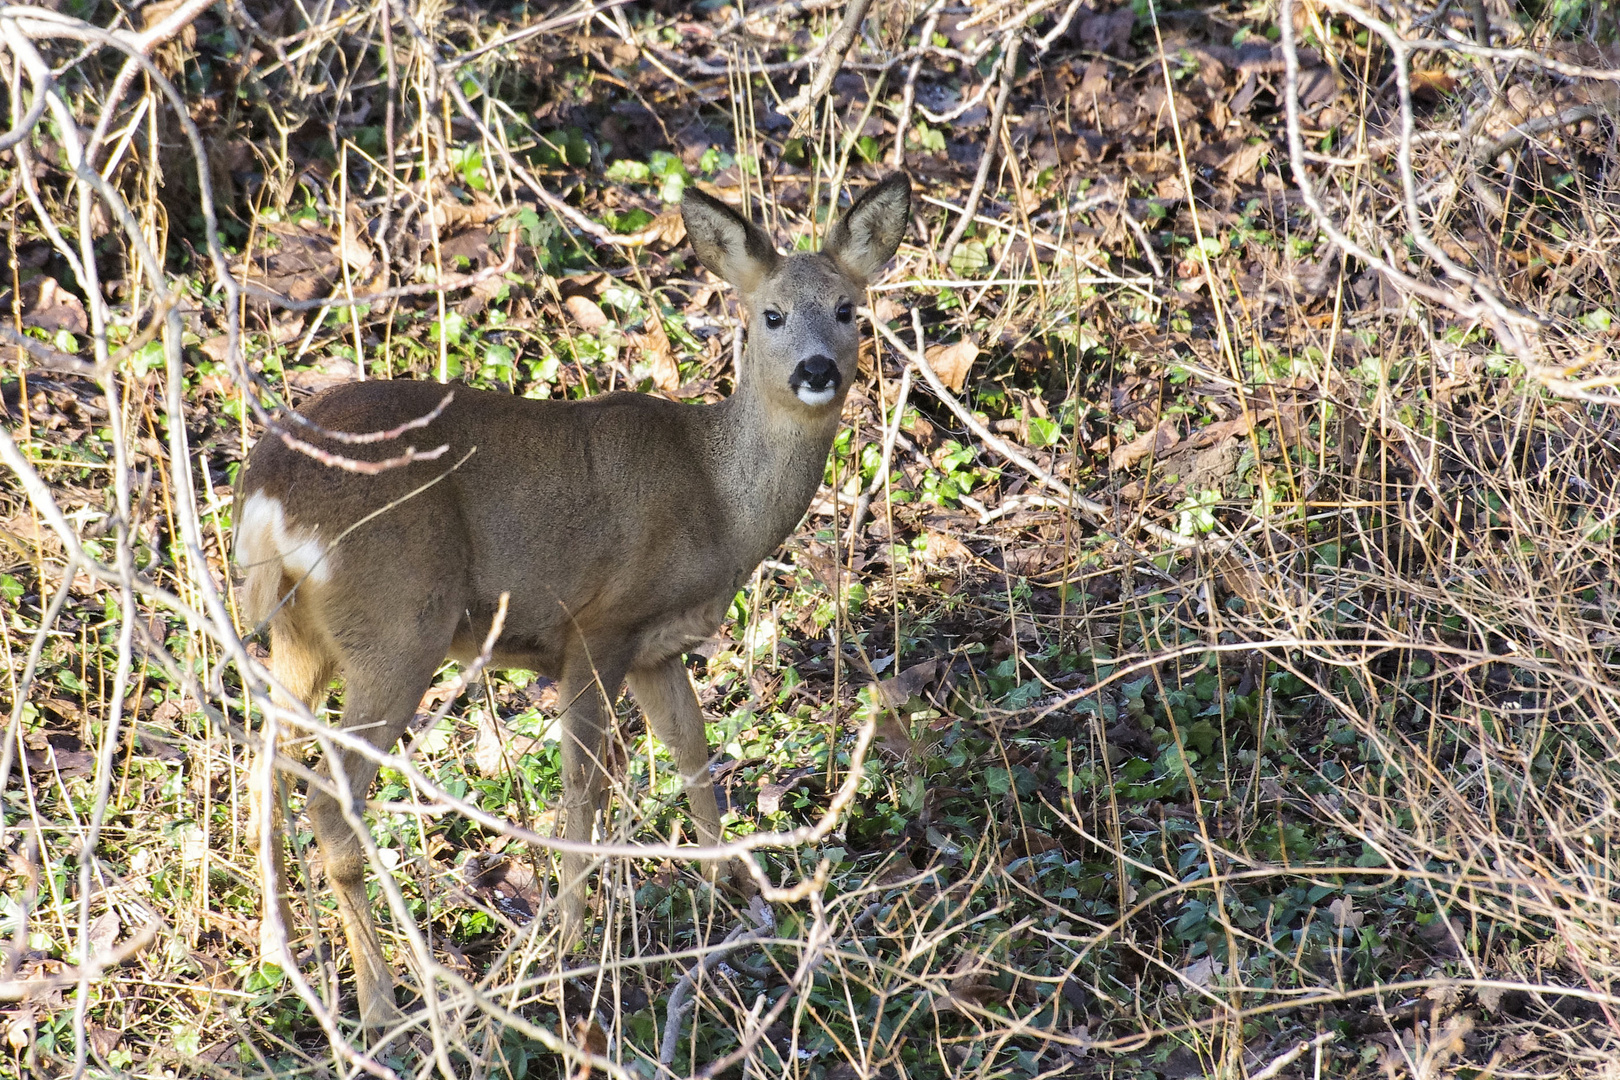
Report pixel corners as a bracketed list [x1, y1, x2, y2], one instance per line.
[235, 173, 910, 1028]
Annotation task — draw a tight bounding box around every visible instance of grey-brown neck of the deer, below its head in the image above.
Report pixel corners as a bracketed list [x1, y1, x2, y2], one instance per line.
[711, 369, 839, 568]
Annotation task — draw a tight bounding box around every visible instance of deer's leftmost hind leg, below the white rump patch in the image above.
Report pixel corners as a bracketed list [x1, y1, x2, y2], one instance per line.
[248, 609, 335, 963]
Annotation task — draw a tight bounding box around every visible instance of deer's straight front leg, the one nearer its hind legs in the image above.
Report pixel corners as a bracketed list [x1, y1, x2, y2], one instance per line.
[557, 646, 624, 952]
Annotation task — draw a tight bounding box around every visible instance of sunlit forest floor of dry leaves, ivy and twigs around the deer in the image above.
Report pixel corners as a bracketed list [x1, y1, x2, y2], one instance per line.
[0, 0, 1620, 1080]
